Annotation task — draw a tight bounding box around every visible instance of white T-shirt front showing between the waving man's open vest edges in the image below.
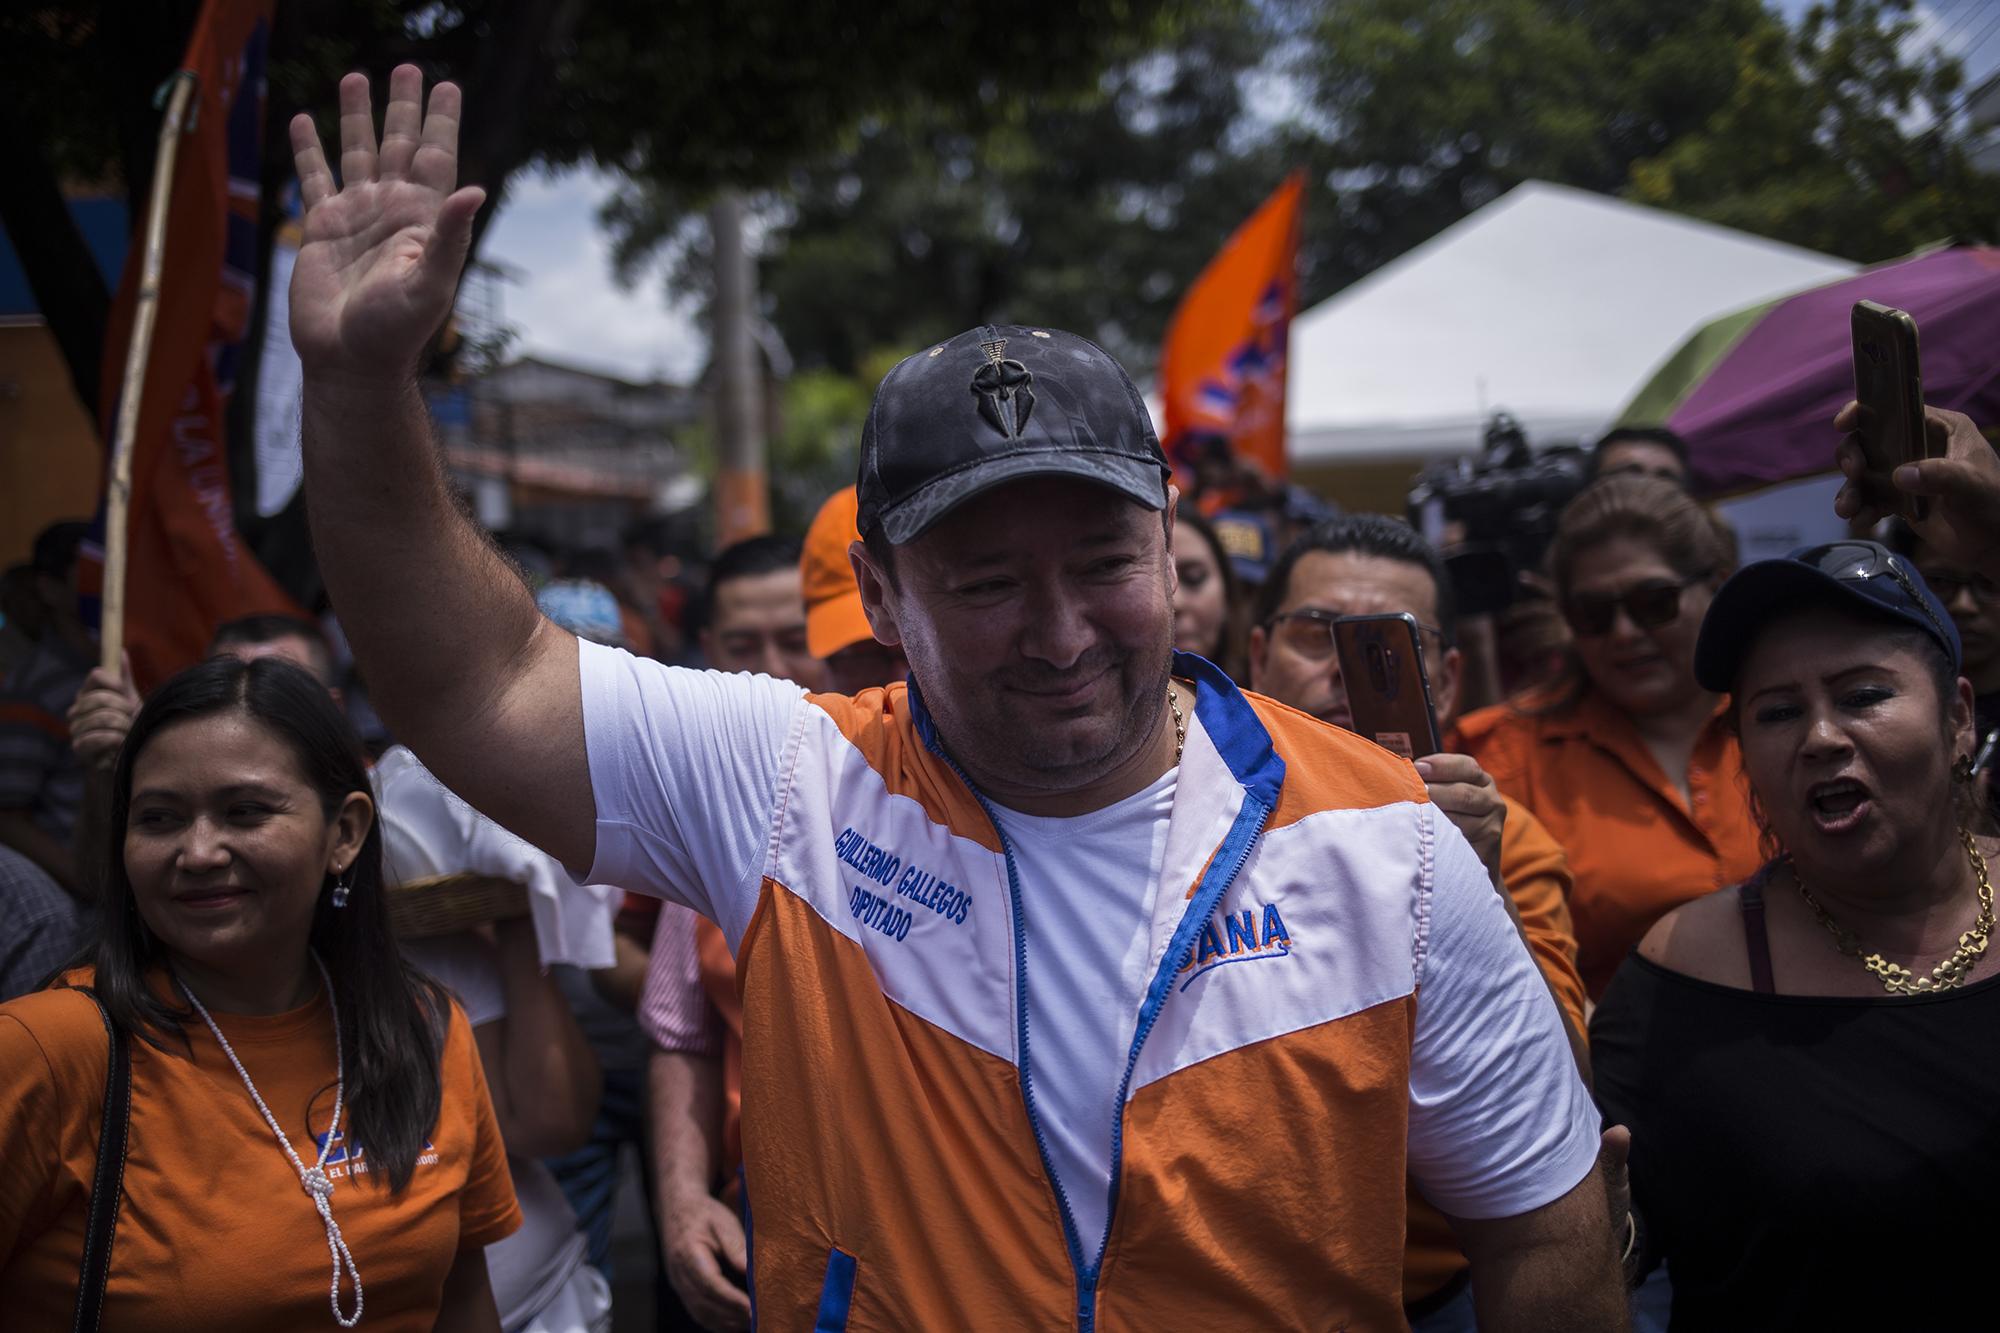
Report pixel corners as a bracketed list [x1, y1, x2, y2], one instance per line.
[994, 769, 1180, 1259]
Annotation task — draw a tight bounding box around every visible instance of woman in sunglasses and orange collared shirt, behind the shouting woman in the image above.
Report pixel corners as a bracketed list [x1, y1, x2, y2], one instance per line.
[1458, 476, 1762, 999]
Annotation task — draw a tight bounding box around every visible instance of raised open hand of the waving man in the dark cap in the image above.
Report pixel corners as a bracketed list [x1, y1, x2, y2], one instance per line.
[292, 64, 486, 386]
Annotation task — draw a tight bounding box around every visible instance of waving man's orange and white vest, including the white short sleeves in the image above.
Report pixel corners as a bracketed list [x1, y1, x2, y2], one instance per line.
[582, 644, 1598, 1329]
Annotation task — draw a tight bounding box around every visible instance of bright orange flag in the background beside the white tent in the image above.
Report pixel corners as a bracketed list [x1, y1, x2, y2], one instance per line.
[1160, 172, 1306, 490]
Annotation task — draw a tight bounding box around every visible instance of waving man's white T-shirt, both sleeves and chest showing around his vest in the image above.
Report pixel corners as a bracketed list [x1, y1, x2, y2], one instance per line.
[580, 642, 1598, 1232]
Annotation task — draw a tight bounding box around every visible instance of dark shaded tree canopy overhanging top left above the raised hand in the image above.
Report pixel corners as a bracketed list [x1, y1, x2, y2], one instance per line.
[0, 0, 1168, 408]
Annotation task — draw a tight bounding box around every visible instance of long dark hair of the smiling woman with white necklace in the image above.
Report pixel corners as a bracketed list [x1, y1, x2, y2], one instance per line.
[92, 656, 450, 1191]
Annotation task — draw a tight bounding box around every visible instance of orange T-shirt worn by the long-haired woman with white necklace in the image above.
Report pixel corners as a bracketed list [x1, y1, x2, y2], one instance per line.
[0, 972, 520, 1331]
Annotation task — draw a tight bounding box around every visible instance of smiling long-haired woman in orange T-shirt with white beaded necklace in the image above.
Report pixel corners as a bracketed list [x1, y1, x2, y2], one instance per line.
[0, 658, 520, 1331]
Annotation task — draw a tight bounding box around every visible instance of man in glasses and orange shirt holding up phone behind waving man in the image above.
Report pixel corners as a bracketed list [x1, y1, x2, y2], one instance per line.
[1250, 514, 1588, 1333]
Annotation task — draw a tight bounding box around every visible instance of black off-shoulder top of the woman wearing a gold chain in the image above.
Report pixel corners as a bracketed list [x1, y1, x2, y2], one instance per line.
[1590, 921, 2000, 1333]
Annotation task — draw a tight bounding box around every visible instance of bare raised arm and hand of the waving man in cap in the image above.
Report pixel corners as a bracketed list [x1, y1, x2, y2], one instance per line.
[292, 66, 596, 871]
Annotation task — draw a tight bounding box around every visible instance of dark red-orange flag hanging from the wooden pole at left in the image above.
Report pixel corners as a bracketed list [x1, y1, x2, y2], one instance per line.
[94, 0, 300, 691]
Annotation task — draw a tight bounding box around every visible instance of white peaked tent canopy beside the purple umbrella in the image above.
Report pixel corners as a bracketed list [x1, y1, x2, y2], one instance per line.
[1286, 182, 1856, 468]
